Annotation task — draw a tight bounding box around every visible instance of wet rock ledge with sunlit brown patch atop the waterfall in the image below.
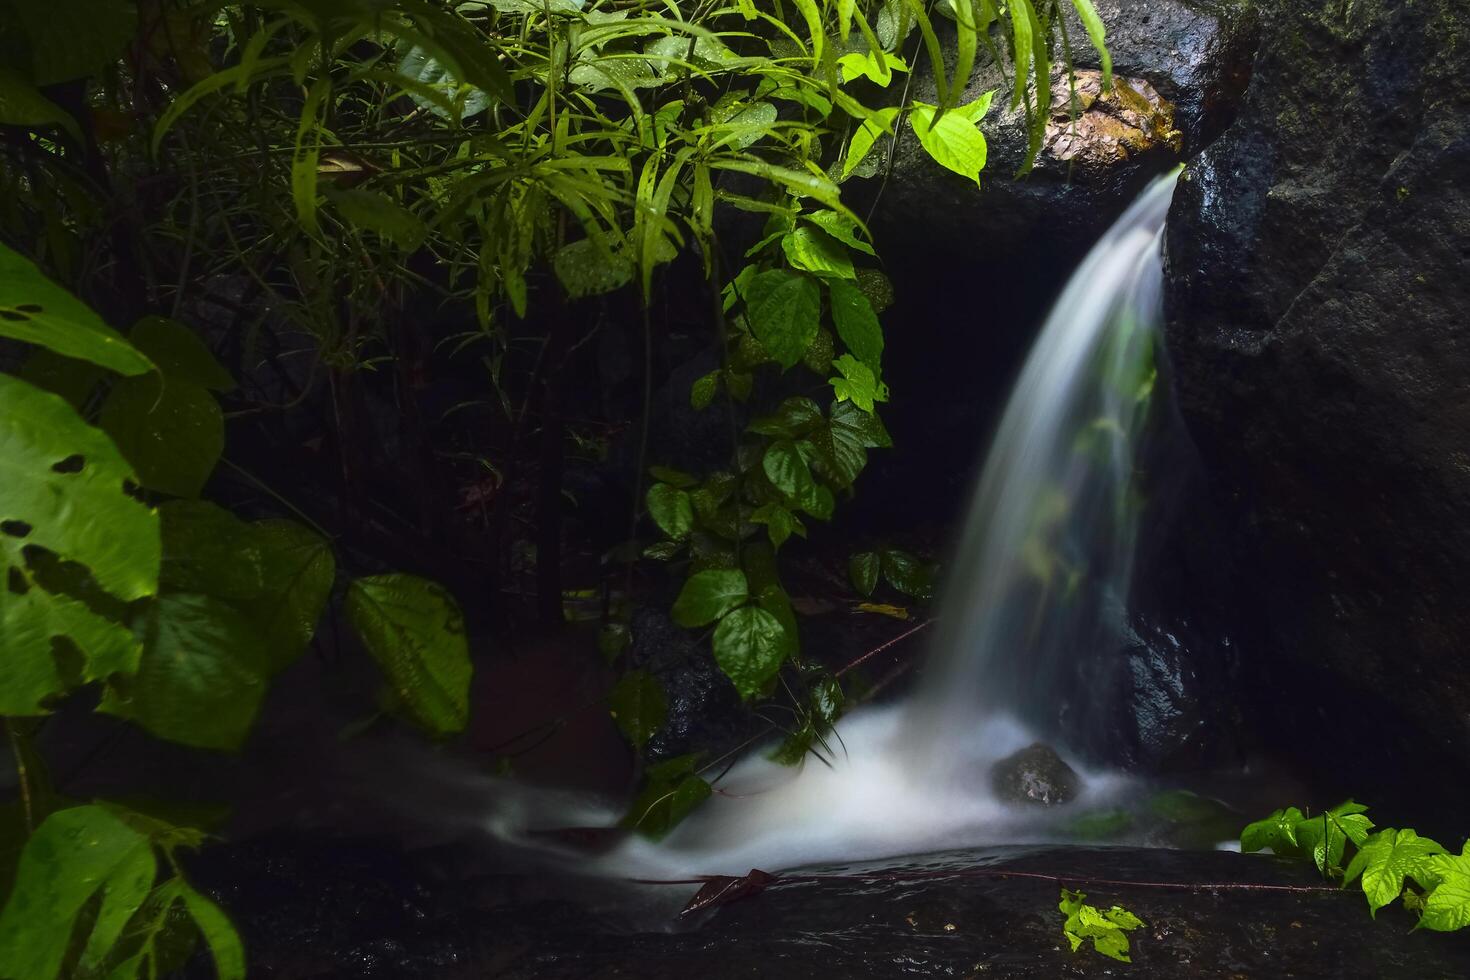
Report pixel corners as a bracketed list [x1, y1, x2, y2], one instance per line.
[875, 0, 1255, 267]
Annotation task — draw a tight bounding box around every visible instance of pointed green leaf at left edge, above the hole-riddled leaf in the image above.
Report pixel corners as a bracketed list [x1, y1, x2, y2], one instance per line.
[0, 244, 153, 375]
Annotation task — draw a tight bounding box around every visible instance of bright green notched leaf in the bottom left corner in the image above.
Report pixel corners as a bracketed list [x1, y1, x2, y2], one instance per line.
[0, 805, 157, 980]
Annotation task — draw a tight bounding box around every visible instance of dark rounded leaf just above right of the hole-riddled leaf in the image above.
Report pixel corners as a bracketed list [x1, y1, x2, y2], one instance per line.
[98, 376, 225, 497]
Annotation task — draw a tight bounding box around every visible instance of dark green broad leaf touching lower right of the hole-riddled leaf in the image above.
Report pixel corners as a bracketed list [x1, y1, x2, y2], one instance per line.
[97, 592, 270, 749]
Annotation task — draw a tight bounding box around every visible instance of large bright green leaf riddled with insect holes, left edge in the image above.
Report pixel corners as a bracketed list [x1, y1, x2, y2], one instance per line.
[0, 373, 159, 716]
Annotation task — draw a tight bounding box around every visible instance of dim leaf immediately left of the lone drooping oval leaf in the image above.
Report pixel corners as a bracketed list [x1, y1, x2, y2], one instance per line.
[240, 520, 337, 671]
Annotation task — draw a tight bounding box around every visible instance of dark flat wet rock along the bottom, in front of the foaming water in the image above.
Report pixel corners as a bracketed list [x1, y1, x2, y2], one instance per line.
[180, 839, 1470, 980]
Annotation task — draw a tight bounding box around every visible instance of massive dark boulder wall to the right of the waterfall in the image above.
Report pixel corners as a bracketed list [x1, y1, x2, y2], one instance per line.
[1167, 0, 1470, 768]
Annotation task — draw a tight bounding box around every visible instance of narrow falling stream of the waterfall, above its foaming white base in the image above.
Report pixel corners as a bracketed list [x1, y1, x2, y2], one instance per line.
[907, 170, 1179, 763]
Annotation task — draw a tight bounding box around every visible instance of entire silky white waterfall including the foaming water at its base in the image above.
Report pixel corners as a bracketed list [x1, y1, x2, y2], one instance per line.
[482, 172, 1177, 877]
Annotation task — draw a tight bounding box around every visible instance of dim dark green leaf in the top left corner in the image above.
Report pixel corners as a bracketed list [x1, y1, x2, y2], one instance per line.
[0, 0, 138, 85]
